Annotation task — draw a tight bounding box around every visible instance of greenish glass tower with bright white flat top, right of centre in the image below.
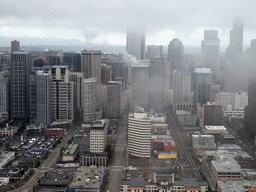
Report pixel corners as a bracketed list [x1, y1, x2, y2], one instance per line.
[193, 68, 212, 113]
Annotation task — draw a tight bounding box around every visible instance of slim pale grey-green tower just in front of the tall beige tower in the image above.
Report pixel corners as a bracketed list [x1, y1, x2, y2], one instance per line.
[83, 77, 97, 122]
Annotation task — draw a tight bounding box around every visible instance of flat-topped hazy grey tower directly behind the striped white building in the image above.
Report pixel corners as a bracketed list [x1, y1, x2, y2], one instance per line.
[131, 63, 149, 111]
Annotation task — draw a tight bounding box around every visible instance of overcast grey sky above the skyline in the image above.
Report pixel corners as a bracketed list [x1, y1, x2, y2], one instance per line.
[0, 0, 256, 47]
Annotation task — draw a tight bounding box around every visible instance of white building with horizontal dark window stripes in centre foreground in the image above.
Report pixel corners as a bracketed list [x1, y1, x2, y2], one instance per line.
[128, 107, 151, 158]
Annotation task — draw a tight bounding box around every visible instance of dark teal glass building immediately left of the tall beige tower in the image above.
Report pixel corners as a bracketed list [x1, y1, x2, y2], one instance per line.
[63, 52, 81, 72]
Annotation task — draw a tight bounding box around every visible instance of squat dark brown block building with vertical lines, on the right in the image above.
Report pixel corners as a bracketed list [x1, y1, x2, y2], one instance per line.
[201, 103, 223, 127]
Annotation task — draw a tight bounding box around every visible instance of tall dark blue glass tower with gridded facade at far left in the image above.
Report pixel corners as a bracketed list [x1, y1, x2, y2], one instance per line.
[10, 52, 31, 121]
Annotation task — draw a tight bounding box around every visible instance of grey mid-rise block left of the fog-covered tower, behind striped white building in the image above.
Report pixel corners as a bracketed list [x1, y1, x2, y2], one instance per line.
[106, 81, 122, 119]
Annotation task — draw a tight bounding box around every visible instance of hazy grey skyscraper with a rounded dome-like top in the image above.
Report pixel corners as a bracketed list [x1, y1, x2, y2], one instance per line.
[168, 39, 184, 88]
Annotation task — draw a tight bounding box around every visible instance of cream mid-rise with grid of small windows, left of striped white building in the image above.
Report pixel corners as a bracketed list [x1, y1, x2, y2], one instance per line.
[90, 119, 107, 153]
